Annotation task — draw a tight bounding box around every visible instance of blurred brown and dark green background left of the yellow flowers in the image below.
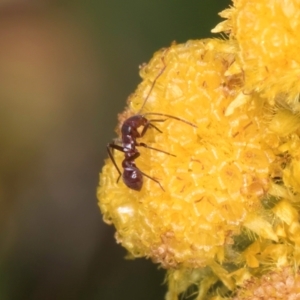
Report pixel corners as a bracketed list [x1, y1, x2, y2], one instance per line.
[0, 0, 230, 300]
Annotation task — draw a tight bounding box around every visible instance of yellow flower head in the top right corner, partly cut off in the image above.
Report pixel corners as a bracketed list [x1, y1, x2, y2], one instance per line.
[212, 0, 300, 112]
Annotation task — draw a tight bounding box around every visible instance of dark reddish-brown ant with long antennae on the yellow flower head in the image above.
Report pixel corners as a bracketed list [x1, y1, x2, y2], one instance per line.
[107, 52, 197, 191]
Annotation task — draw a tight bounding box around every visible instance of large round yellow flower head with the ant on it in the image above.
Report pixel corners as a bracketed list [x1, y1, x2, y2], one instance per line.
[98, 40, 300, 274]
